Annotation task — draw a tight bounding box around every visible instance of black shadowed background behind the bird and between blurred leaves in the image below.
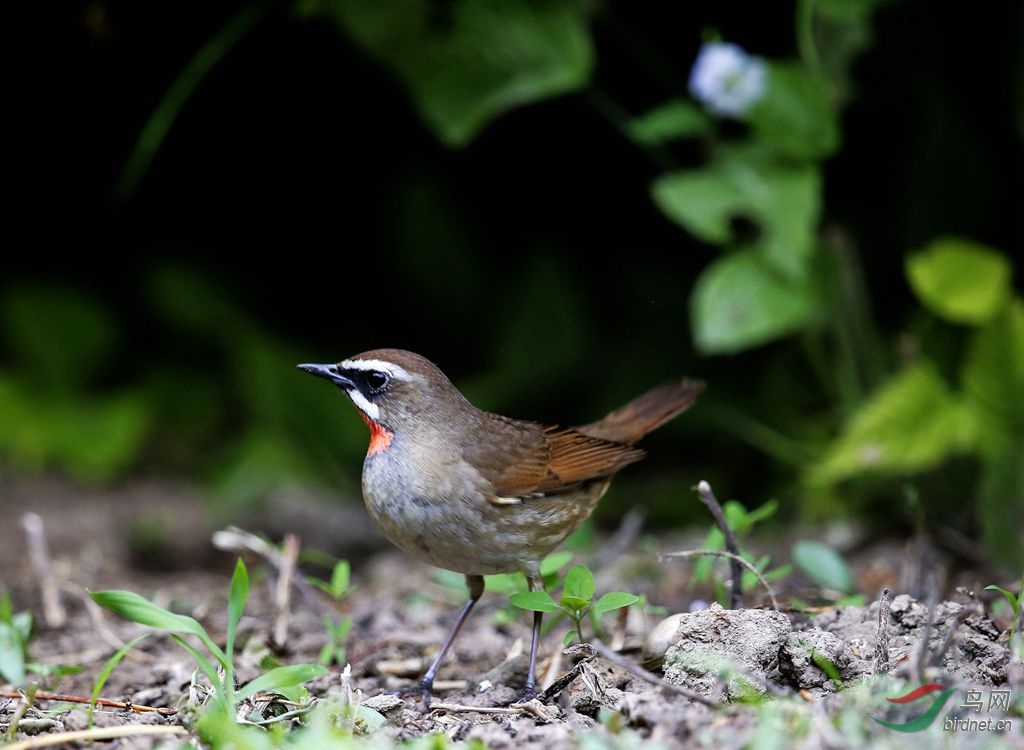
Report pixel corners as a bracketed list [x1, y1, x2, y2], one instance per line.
[6, 0, 1022, 540]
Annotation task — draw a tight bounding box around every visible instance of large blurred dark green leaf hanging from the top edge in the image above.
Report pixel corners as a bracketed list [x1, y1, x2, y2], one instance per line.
[310, 0, 594, 147]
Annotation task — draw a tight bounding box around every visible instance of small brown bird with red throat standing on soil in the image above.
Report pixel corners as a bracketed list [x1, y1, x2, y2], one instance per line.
[298, 349, 703, 705]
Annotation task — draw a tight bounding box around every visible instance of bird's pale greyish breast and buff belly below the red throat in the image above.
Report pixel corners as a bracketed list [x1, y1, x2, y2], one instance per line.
[362, 459, 608, 577]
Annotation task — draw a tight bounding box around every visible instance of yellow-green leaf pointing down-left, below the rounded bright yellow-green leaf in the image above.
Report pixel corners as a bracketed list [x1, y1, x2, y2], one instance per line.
[808, 360, 977, 485]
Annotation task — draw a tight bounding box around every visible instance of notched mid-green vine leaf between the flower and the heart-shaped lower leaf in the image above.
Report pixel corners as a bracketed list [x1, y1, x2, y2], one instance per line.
[651, 145, 821, 279]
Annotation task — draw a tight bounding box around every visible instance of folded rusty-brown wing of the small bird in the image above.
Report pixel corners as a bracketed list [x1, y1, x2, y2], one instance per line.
[466, 415, 644, 498]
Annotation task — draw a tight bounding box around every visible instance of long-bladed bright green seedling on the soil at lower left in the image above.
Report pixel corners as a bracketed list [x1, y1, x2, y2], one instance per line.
[91, 559, 327, 716]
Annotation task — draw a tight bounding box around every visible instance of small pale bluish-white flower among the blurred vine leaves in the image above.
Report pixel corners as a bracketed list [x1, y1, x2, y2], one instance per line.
[689, 42, 768, 118]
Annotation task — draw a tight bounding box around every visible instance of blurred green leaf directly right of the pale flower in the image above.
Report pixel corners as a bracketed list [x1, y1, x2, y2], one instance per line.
[746, 63, 840, 160]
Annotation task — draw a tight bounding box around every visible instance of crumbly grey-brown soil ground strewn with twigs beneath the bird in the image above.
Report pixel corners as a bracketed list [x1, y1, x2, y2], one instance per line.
[0, 477, 1024, 749]
